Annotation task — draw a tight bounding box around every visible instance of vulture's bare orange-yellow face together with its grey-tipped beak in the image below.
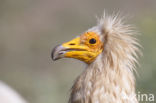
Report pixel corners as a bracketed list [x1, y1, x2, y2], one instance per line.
[52, 32, 103, 64]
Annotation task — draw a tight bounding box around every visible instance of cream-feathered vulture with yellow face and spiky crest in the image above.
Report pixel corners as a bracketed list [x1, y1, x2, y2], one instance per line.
[51, 15, 140, 103]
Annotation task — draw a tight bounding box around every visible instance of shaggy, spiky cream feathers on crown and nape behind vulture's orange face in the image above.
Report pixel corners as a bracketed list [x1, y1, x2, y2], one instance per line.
[88, 13, 141, 70]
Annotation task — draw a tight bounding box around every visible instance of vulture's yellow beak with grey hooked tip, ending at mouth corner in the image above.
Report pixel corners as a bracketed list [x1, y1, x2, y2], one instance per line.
[51, 37, 88, 60]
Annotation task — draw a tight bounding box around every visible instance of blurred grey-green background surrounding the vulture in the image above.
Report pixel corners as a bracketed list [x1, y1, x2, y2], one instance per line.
[0, 0, 156, 103]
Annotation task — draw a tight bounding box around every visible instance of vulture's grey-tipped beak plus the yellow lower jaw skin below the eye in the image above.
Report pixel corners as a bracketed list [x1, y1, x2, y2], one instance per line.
[51, 37, 96, 63]
